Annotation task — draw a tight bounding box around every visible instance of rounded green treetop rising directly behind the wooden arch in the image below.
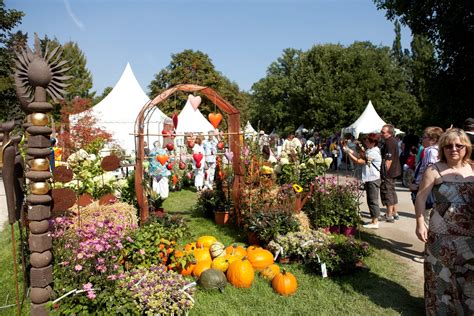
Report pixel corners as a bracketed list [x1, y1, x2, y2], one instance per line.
[148, 49, 248, 118]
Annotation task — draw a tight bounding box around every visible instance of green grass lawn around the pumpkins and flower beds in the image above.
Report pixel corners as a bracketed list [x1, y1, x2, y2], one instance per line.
[0, 190, 424, 315]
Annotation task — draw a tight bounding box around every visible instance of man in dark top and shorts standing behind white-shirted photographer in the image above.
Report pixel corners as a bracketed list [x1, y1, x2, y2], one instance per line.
[380, 124, 401, 223]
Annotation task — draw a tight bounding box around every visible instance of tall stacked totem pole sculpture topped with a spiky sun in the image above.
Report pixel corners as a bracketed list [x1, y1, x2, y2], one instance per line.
[14, 34, 71, 315]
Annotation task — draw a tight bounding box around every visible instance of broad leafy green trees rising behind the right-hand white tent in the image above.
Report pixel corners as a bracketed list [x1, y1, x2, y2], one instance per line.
[250, 42, 420, 132]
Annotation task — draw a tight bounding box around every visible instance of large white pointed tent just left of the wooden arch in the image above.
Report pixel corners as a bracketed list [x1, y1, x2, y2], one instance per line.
[92, 63, 168, 152]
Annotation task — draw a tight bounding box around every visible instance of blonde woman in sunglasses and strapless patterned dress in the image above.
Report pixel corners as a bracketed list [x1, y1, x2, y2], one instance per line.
[415, 129, 474, 315]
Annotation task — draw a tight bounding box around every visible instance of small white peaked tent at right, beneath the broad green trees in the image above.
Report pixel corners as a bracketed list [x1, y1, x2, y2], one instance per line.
[342, 100, 403, 138]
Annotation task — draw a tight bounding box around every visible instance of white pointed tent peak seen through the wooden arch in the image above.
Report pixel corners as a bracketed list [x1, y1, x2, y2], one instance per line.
[176, 100, 214, 134]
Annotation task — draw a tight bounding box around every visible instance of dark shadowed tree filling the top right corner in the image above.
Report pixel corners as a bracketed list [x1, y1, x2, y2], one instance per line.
[374, 0, 474, 126]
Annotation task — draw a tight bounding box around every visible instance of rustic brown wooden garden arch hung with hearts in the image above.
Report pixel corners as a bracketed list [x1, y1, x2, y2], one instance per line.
[135, 84, 243, 225]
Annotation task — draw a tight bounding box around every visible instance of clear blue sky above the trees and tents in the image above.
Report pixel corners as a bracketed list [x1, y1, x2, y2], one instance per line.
[5, 0, 411, 94]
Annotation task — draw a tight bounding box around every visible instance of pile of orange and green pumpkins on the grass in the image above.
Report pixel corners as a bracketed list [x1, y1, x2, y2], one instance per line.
[181, 236, 298, 296]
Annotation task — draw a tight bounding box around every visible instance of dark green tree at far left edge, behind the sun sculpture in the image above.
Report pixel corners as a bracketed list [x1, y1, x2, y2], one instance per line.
[0, 0, 26, 122]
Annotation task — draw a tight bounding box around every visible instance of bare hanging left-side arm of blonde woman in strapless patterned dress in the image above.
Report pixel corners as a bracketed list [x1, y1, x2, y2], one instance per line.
[415, 166, 438, 242]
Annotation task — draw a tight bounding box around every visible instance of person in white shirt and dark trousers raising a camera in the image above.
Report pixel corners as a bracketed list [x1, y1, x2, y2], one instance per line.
[343, 133, 382, 229]
